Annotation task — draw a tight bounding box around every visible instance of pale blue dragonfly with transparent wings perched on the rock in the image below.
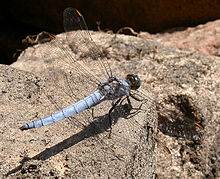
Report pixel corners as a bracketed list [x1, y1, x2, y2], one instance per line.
[20, 8, 153, 145]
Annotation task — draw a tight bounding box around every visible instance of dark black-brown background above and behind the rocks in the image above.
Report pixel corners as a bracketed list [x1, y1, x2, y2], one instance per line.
[0, 0, 220, 64]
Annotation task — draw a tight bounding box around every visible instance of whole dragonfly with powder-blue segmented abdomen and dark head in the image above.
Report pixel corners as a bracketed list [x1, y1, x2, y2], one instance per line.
[20, 8, 148, 130]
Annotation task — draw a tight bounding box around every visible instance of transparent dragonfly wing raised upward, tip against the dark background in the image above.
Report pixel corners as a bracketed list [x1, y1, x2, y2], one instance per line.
[63, 8, 112, 78]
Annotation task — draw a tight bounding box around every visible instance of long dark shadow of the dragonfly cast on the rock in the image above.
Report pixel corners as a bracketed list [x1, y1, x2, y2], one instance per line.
[6, 104, 133, 177]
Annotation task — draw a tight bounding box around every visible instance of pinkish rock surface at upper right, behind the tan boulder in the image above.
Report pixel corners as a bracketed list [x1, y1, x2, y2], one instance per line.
[138, 20, 220, 56]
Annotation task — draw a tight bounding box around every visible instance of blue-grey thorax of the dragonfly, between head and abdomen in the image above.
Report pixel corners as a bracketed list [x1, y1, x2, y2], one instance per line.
[98, 76, 131, 100]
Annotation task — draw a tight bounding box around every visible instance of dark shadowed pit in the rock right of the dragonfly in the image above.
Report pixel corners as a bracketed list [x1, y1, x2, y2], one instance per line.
[158, 95, 204, 143]
